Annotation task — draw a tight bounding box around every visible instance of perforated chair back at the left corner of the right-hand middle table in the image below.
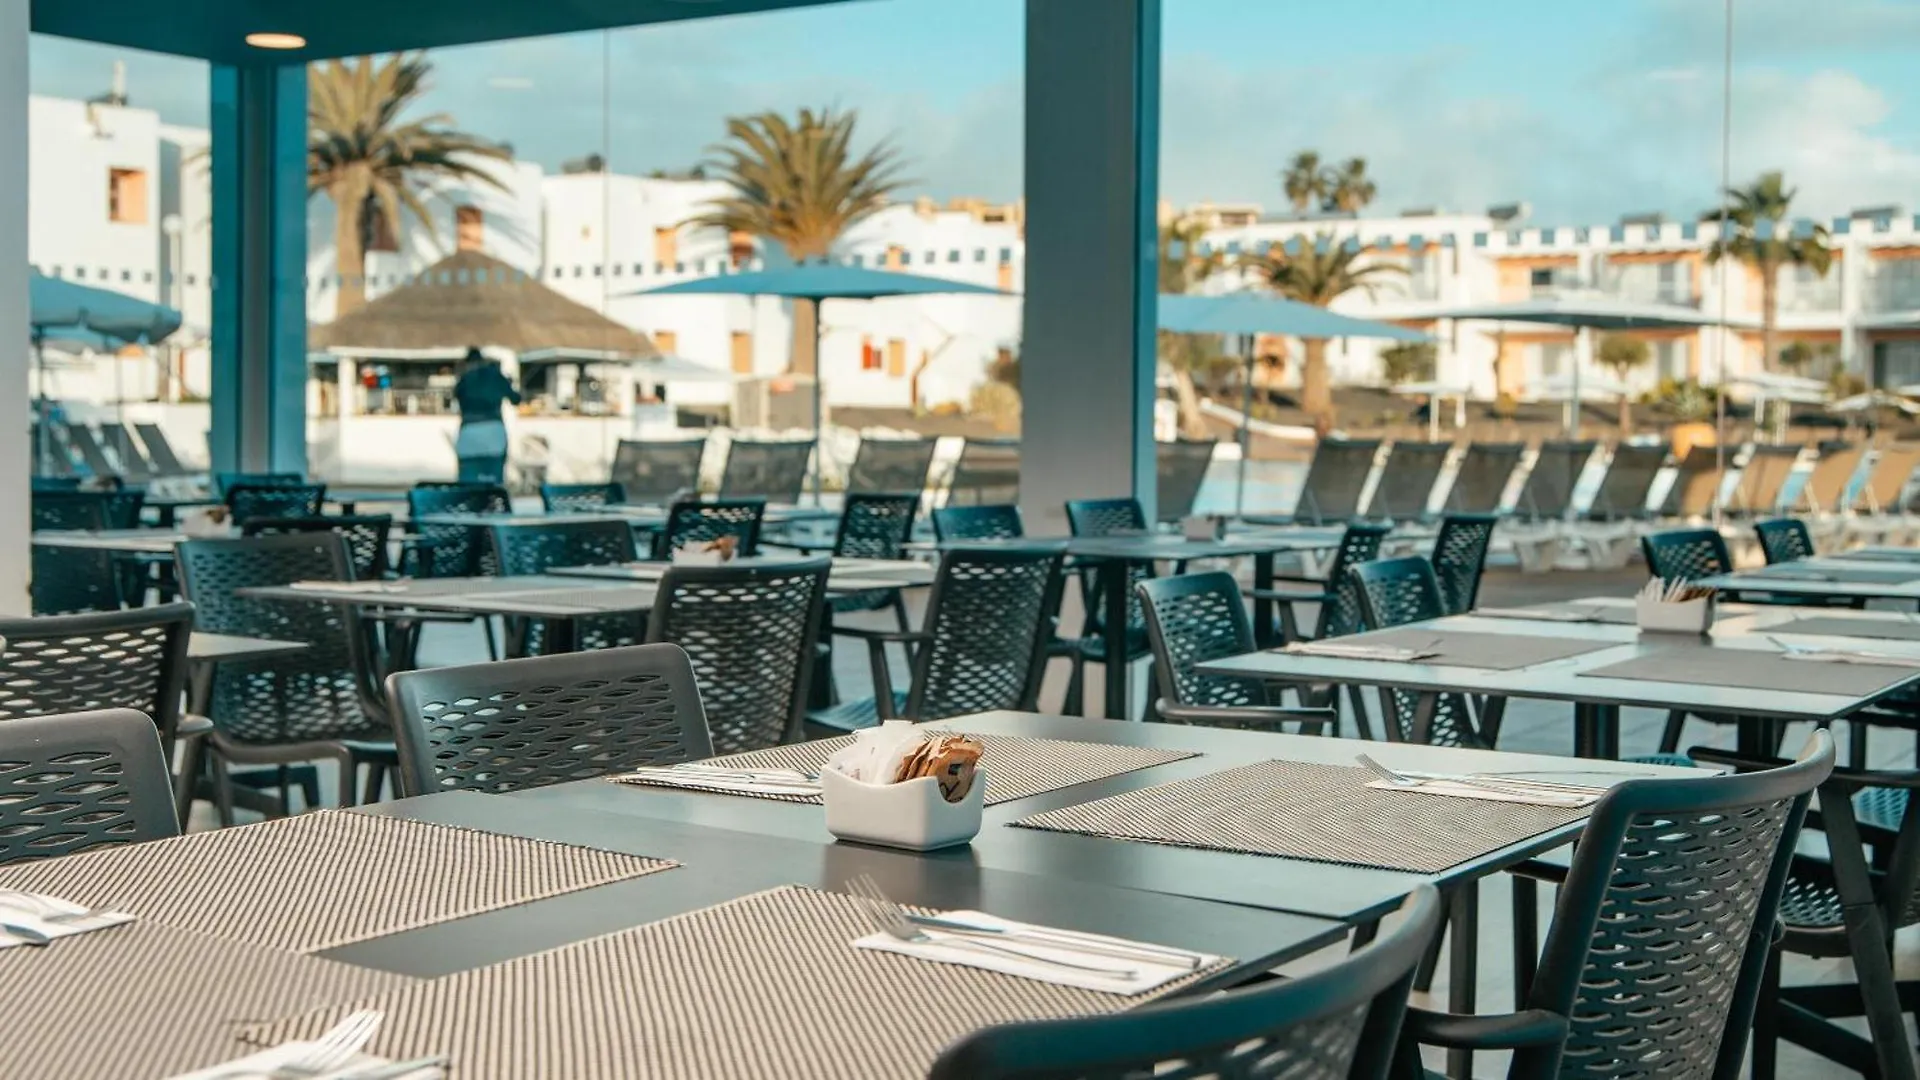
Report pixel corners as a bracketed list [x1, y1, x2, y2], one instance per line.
[1137, 571, 1271, 707]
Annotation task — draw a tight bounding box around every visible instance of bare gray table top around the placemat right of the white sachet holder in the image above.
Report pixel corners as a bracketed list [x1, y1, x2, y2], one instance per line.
[507, 711, 1697, 922]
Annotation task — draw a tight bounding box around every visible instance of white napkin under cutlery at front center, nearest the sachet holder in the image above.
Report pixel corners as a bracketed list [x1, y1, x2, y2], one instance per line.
[852, 911, 1223, 995]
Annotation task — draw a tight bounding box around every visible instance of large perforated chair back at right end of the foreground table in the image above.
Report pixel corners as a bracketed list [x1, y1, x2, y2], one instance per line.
[1526, 730, 1834, 1080]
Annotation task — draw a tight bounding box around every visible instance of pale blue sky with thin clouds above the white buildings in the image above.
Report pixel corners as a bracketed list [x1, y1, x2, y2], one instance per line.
[33, 0, 1920, 221]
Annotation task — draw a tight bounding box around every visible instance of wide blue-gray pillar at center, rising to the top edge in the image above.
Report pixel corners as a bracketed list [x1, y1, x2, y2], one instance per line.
[1020, 0, 1160, 534]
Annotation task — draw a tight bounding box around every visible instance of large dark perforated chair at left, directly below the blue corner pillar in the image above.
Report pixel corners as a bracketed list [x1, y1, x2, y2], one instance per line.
[175, 530, 399, 824]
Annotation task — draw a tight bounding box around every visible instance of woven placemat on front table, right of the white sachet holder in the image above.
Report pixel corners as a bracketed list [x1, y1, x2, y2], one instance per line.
[1014, 761, 1592, 874]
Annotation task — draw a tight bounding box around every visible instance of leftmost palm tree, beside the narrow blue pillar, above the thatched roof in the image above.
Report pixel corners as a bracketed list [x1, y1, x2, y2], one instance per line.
[307, 52, 511, 317]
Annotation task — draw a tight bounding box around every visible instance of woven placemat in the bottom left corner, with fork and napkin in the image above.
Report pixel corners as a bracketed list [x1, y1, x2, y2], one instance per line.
[0, 922, 417, 1078]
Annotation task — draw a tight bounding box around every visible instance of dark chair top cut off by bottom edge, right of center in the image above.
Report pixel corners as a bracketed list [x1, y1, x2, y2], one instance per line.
[927, 886, 1440, 1080]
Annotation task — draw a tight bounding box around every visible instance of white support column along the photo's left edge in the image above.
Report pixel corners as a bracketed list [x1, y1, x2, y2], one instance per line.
[0, 4, 33, 615]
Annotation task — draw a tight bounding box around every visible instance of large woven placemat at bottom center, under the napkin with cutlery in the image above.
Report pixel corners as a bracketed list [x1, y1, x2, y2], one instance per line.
[248, 886, 1215, 1080]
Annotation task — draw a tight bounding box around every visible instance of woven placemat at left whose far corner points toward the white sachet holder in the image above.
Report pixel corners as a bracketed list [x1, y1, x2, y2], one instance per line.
[0, 811, 676, 953]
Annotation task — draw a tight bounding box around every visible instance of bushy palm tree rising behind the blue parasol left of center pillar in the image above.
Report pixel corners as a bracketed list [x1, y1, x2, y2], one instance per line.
[693, 110, 908, 375]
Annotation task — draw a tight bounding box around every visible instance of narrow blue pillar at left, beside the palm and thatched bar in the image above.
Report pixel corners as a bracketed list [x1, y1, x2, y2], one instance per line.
[209, 63, 307, 473]
